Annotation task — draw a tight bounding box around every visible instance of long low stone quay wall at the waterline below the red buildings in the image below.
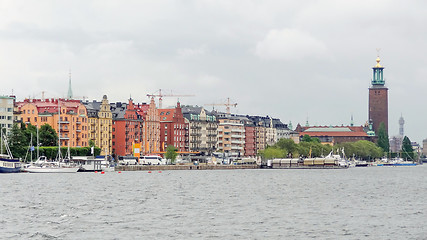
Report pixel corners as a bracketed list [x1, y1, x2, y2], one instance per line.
[115, 164, 260, 171]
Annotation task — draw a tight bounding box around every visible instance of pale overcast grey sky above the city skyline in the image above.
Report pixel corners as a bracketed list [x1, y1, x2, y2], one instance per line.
[0, 0, 427, 143]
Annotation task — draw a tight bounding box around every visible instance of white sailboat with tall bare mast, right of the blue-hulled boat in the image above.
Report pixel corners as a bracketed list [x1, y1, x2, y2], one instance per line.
[23, 100, 80, 173]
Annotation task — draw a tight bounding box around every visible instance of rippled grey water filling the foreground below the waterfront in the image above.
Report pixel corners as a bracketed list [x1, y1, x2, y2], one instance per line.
[0, 166, 427, 239]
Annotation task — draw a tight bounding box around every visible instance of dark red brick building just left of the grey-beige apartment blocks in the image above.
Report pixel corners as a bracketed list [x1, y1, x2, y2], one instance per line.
[158, 102, 189, 152]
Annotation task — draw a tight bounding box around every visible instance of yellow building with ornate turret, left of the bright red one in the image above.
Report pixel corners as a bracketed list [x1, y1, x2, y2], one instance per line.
[84, 95, 113, 155]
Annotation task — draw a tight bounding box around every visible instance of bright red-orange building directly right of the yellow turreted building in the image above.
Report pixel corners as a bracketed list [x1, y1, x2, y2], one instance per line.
[110, 99, 143, 156]
